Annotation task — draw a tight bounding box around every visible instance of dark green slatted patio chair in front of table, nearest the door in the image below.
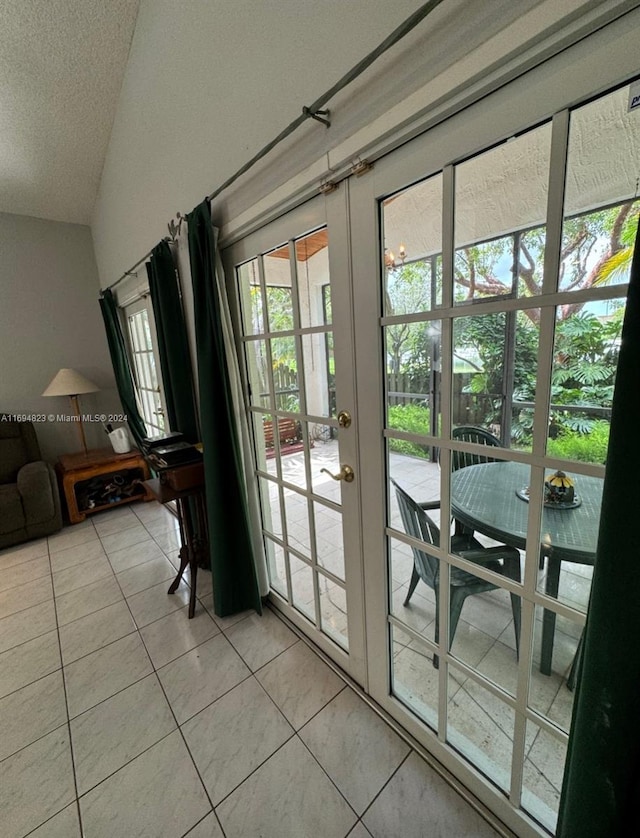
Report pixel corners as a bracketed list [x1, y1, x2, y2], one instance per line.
[391, 478, 521, 669]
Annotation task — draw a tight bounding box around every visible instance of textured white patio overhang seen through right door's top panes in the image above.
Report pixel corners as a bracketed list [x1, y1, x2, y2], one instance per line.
[384, 86, 640, 260]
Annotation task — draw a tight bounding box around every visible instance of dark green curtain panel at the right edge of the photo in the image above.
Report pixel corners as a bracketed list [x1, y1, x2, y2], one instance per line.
[556, 220, 640, 838]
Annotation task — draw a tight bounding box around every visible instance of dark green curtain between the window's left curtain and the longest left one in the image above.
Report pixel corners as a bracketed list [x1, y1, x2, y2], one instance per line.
[147, 241, 200, 442]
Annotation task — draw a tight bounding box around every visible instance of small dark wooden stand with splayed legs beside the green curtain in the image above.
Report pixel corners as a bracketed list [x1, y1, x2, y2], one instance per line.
[145, 466, 209, 619]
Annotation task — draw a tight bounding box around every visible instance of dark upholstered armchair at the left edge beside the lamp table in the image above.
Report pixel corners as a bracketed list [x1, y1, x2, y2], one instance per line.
[0, 415, 62, 548]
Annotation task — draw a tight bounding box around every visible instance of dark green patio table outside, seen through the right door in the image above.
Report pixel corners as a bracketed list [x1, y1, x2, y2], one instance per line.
[451, 462, 603, 675]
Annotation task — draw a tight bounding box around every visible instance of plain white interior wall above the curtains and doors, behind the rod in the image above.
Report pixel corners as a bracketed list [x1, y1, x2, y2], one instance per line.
[92, 0, 556, 287]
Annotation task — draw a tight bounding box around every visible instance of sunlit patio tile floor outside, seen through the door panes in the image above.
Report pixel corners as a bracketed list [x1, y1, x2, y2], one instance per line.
[267, 440, 593, 832]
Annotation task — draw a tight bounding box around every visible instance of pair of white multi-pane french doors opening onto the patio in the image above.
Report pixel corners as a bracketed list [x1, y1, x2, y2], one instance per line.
[225, 13, 640, 836]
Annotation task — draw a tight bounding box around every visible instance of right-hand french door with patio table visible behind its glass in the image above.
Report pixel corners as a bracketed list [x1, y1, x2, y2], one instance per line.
[349, 52, 640, 835]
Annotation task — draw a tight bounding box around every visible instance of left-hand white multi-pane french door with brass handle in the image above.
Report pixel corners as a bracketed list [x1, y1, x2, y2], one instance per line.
[225, 190, 366, 685]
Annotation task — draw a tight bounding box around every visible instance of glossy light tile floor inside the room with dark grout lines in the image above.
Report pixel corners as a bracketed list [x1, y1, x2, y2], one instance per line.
[0, 504, 504, 838]
